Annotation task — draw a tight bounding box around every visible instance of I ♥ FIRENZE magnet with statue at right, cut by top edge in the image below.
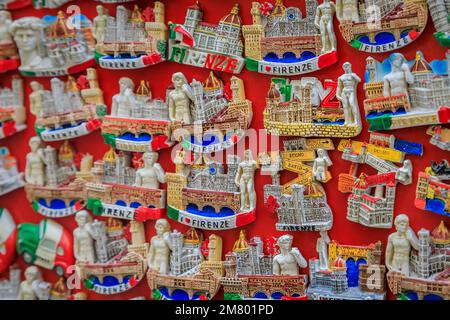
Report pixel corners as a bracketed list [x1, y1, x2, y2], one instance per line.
[242, 0, 338, 76]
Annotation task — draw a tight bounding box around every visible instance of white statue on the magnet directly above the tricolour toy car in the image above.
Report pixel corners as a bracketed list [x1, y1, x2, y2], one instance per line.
[25, 137, 45, 186]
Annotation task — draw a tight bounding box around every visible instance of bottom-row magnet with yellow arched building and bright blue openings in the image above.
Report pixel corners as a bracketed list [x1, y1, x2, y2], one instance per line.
[307, 238, 386, 300]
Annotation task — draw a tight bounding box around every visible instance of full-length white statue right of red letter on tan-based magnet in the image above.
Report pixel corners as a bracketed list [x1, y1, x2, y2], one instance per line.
[336, 62, 361, 126]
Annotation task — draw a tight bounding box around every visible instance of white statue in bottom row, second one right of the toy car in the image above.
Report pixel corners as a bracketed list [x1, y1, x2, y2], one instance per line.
[147, 219, 172, 274]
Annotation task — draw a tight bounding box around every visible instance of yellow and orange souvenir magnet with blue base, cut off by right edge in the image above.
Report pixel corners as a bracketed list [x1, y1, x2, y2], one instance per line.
[414, 159, 450, 217]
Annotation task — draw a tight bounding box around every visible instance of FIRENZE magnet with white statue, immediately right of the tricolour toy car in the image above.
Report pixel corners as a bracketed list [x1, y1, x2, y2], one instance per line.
[73, 210, 149, 295]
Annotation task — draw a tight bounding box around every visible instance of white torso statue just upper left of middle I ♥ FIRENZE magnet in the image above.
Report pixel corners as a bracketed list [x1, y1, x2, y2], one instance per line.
[134, 152, 166, 189]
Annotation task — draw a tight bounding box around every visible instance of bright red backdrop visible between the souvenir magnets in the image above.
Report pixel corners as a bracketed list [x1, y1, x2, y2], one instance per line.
[0, 0, 450, 299]
